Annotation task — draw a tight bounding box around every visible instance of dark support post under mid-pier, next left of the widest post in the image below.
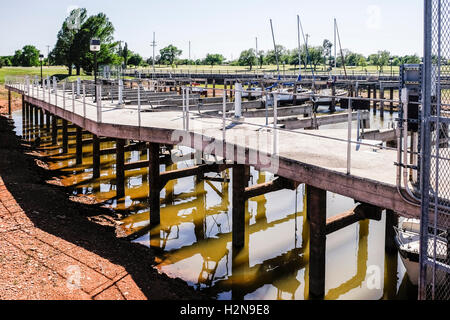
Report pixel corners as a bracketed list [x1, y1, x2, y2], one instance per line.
[232, 164, 247, 248]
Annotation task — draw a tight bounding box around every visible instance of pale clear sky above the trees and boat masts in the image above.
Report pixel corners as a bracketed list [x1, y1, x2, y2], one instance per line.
[0, 0, 423, 59]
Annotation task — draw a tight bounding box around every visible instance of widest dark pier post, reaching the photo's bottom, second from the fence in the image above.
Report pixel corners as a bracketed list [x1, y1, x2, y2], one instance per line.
[307, 186, 327, 299]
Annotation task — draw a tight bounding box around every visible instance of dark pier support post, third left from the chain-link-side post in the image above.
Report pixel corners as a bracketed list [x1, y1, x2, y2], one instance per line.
[148, 143, 161, 227]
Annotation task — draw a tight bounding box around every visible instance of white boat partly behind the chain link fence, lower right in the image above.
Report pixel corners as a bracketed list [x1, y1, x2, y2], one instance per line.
[395, 219, 447, 286]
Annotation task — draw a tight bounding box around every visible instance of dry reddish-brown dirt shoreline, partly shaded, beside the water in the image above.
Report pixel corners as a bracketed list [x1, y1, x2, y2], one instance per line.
[0, 101, 205, 300]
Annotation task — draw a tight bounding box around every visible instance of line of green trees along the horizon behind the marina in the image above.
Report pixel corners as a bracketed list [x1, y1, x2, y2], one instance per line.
[0, 8, 421, 75]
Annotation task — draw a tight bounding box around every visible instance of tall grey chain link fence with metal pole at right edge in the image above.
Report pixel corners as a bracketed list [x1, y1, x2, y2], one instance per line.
[419, 0, 450, 300]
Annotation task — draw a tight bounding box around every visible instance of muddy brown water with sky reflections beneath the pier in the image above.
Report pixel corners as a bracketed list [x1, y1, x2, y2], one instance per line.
[13, 111, 417, 300]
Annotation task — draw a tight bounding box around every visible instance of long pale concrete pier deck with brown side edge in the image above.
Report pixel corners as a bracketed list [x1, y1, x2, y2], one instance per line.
[6, 86, 420, 218]
